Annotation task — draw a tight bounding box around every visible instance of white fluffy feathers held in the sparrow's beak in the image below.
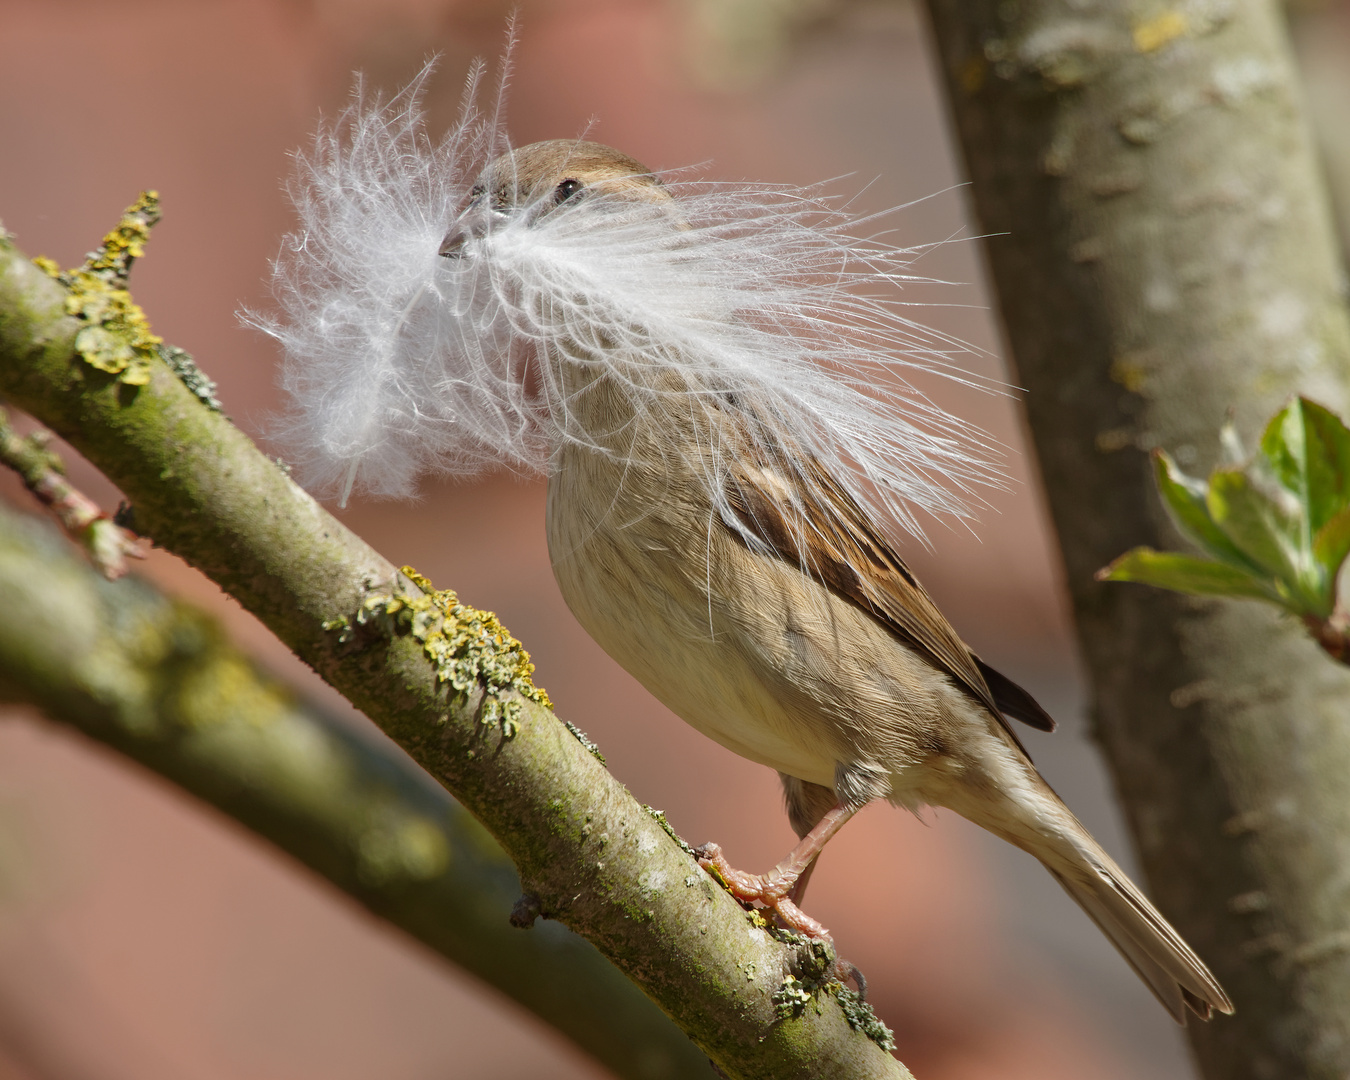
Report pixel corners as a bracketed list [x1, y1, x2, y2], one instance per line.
[251, 59, 1000, 536]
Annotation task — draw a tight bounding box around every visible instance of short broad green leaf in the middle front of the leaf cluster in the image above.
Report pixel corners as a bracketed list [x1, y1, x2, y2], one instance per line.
[1206, 468, 1323, 605]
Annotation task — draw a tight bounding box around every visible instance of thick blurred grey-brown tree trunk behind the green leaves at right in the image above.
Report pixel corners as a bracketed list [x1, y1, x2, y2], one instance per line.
[929, 0, 1350, 1080]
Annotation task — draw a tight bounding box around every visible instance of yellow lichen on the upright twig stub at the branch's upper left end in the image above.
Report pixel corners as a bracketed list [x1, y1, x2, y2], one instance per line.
[34, 192, 163, 386]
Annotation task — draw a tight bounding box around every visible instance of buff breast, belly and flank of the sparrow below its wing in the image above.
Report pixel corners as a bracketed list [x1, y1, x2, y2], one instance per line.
[547, 429, 960, 797]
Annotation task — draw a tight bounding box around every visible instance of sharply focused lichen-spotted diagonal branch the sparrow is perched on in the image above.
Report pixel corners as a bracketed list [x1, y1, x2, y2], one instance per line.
[0, 214, 907, 1080]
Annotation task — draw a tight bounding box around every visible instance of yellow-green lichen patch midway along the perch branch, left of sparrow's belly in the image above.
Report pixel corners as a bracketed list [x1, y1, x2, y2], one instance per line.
[351, 566, 554, 738]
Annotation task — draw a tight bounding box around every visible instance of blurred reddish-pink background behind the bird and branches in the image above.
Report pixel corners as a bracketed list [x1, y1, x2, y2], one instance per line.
[0, 0, 1346, 1080]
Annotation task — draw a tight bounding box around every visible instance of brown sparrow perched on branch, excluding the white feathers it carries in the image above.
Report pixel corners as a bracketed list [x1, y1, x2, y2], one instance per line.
[437, 139, 1233, 1023]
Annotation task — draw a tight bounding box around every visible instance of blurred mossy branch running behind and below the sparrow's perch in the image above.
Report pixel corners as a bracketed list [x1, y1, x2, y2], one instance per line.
[0, 505, 711, 1080]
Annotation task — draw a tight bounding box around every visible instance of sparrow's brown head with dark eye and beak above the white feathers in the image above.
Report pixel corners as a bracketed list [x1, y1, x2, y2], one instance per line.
[440, 139, 672, 258]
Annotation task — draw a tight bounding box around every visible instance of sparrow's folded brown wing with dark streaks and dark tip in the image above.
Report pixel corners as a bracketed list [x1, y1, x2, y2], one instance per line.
[726, 450, 1054, 745]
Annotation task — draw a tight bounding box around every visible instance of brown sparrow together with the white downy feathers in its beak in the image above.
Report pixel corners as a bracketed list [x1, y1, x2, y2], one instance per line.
[259, 88, 1233, 1023]
